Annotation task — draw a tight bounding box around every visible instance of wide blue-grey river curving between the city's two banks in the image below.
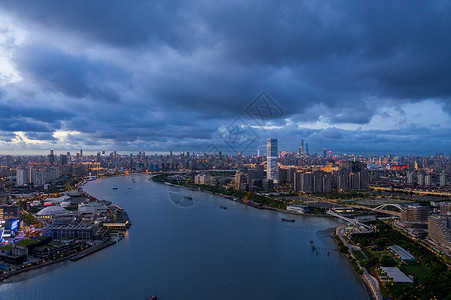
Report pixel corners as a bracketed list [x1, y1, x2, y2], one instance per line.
[0, 175, 368, 300]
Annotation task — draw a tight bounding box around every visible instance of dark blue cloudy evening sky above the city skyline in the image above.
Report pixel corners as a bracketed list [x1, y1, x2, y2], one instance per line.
[0, 0, 451, 154]
